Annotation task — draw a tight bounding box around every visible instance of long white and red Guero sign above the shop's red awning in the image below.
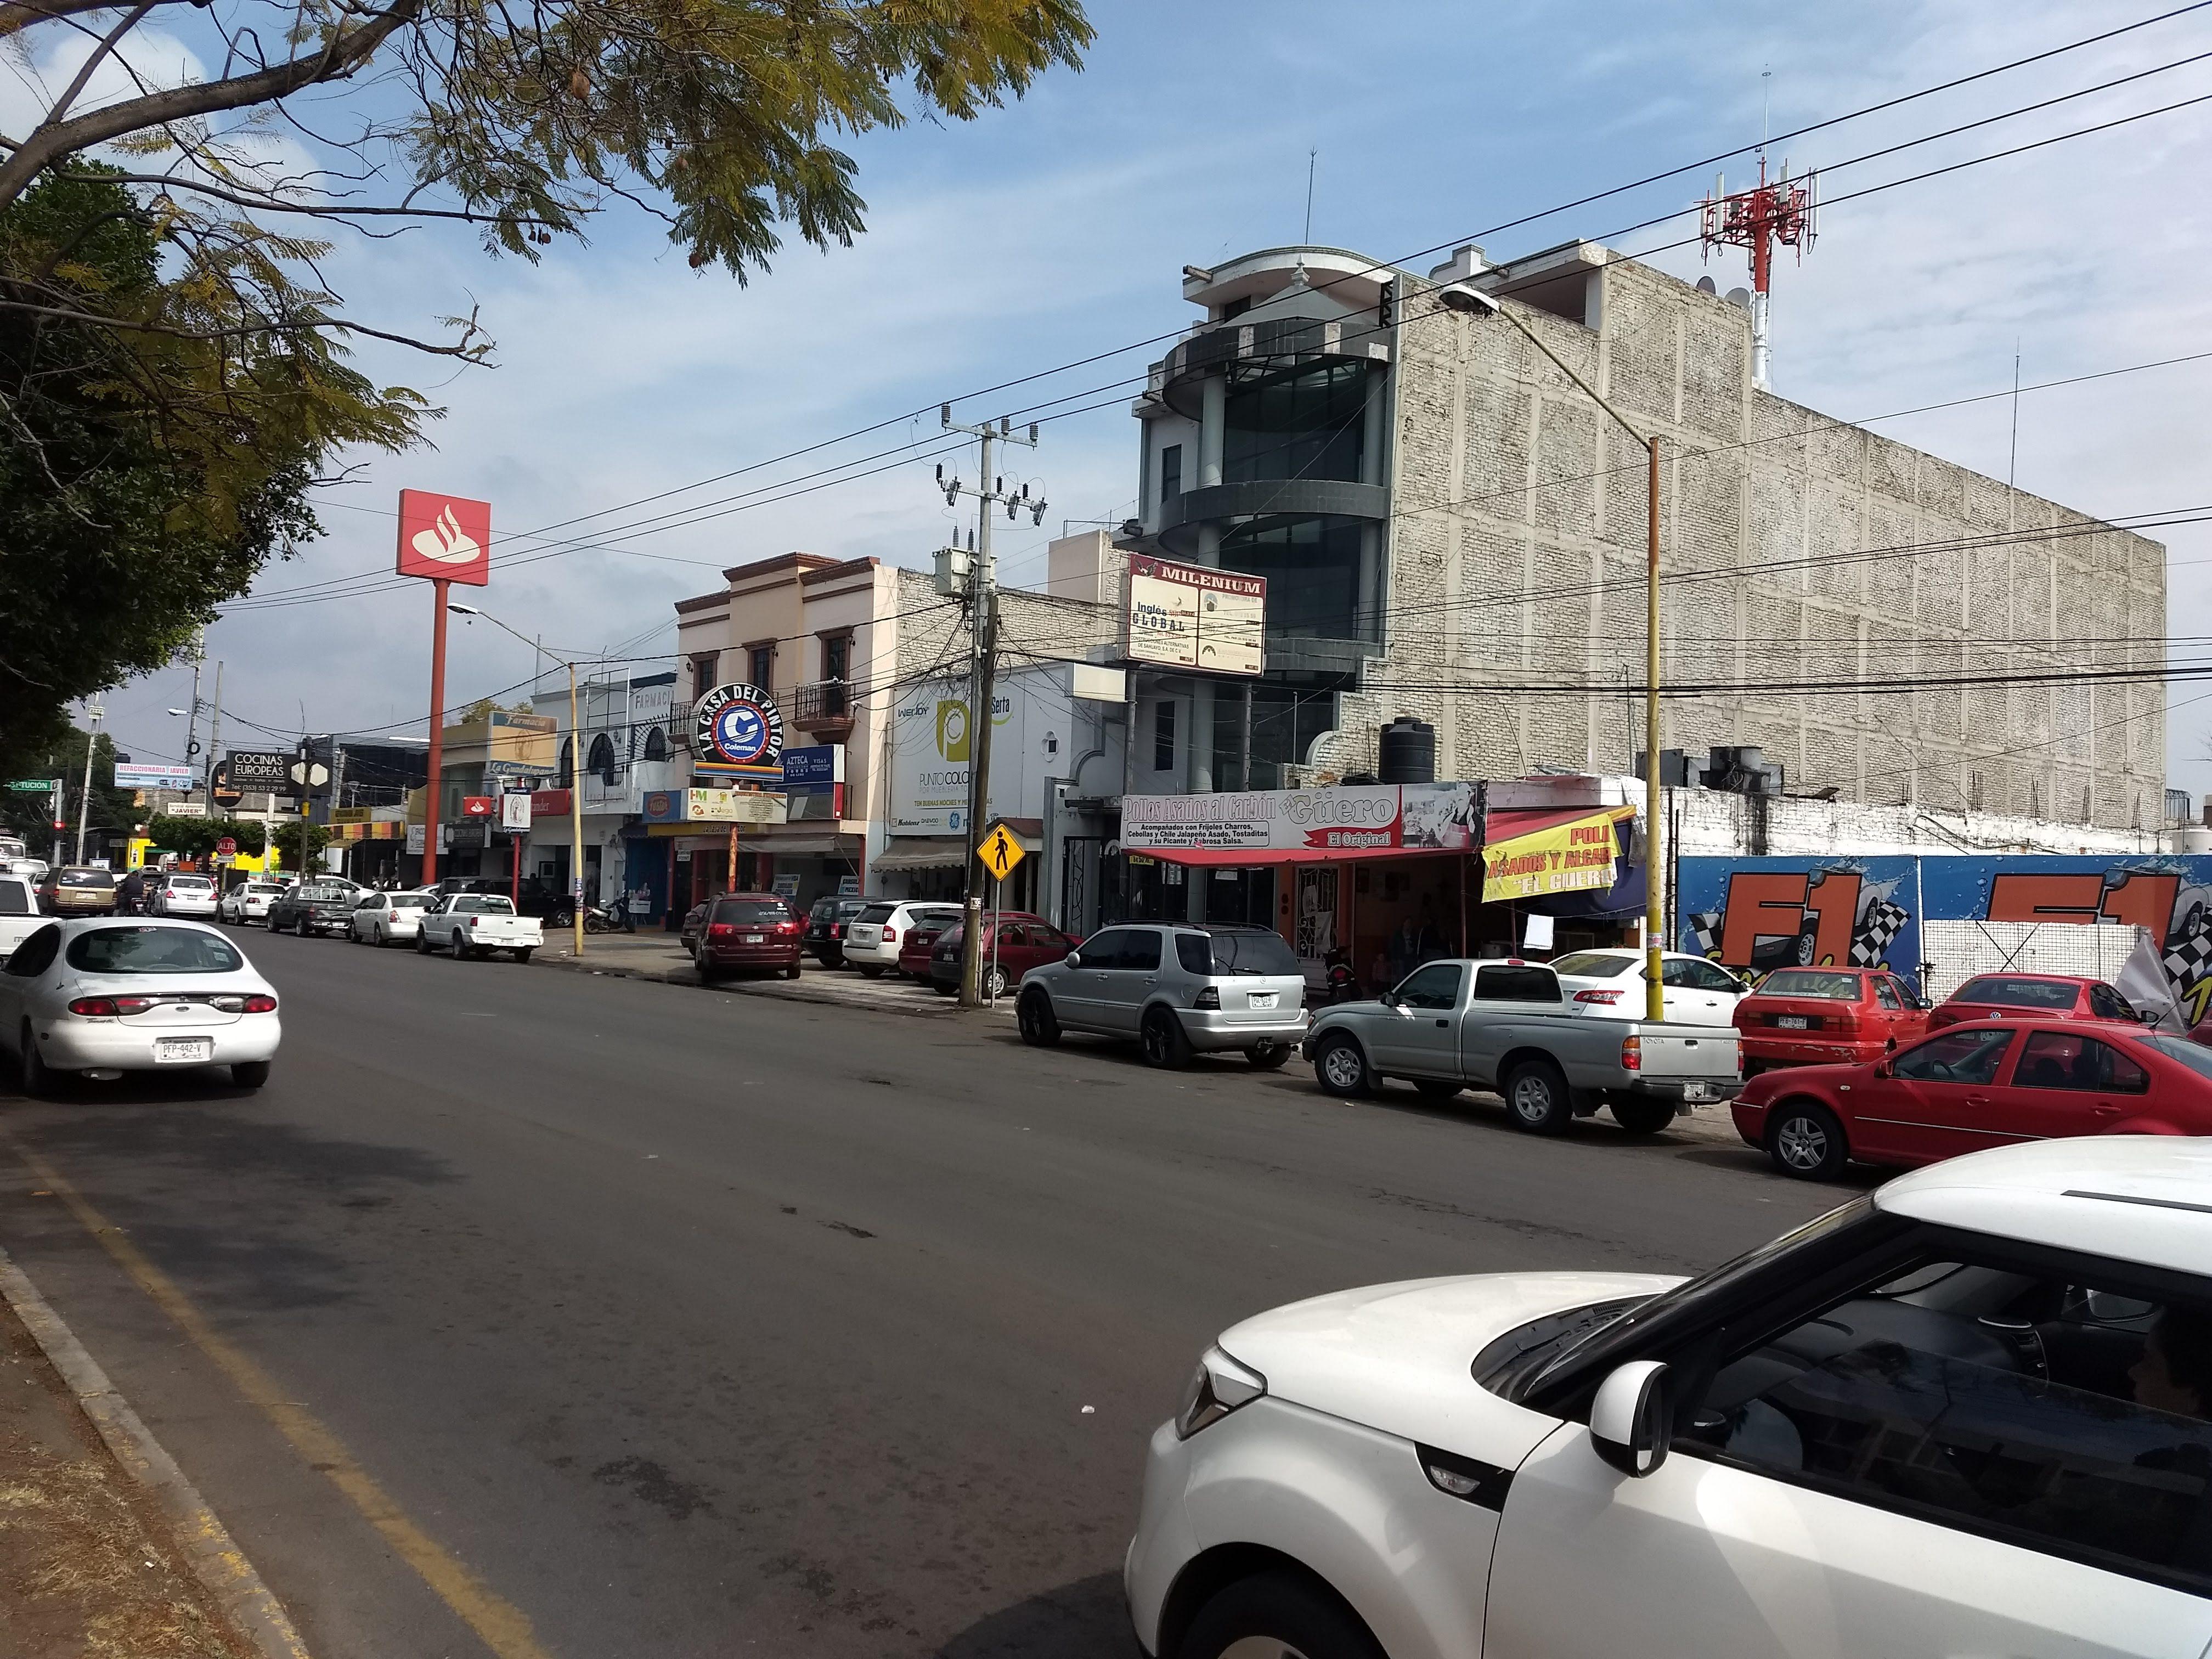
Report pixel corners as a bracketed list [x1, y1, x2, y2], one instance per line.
[1121, 783, 1475, 862]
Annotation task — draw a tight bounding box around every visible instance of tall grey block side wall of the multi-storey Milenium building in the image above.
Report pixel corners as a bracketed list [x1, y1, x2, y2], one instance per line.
[1316, 248, 2165, 830]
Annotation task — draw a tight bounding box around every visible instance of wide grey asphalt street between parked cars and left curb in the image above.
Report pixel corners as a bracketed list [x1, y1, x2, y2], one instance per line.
[0, 934, 1836, 1659]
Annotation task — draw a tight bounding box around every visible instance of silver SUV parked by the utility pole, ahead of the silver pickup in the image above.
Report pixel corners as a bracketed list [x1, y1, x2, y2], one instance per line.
[1018, 922, 1305, 1070]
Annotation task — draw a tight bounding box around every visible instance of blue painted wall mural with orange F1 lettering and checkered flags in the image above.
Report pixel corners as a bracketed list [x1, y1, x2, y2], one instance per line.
[1677, 854, 2212, 1024]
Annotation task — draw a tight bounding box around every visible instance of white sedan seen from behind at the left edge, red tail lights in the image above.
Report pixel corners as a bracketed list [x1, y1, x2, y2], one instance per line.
[0, 916, 283, 1095]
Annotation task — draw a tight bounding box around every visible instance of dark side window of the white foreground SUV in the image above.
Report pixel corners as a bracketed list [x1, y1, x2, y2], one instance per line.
[1674, 1261, 2212, 1595]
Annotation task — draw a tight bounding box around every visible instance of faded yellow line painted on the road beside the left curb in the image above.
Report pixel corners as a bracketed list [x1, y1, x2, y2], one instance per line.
[0, 1128, 549, 1659]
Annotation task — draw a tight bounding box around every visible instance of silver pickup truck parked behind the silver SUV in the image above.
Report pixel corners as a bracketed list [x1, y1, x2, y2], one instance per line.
[1301, 962, 1743, 1135]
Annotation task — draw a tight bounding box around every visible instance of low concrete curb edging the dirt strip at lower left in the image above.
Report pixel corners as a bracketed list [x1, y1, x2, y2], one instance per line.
[0, 1250, 307, 1659]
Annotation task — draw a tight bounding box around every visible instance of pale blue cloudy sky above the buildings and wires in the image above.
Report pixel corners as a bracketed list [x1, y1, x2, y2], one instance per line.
[47, 0, 2212, 792]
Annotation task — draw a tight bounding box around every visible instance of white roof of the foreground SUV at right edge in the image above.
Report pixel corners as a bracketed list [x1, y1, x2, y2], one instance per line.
[1874, 1135, 2212, 1274]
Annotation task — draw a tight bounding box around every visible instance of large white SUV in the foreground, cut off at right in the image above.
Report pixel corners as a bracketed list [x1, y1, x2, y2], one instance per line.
[1124, 1137, 2212, 1659]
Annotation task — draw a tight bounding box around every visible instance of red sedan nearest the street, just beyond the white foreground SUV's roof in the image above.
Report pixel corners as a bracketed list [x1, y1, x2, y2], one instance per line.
[1730, 1020, 2212, 1181]
